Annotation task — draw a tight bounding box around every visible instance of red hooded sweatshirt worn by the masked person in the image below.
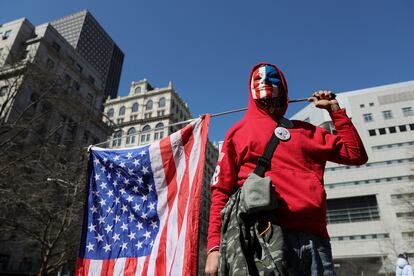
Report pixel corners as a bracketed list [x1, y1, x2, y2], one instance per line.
[207, 63, 368, 251]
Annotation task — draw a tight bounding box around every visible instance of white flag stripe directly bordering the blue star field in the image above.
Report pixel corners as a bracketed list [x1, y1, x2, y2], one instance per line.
[147, 143, 168, 275]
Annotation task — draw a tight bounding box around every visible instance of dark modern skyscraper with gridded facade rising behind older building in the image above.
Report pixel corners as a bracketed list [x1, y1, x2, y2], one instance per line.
[50, 10, 124, 101]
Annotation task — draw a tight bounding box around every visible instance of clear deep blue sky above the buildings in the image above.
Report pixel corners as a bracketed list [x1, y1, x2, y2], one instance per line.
[0, 0, 414, 141]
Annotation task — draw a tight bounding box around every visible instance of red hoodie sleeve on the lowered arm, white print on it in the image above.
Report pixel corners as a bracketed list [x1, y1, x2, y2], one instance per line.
[207, 135, 237, 252]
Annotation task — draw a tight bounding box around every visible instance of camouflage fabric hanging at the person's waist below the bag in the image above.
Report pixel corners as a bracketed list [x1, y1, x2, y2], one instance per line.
[218, 189, 288, 276]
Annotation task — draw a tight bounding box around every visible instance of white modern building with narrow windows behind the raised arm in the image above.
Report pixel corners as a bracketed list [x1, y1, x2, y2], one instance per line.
[292, 81, 414, 275]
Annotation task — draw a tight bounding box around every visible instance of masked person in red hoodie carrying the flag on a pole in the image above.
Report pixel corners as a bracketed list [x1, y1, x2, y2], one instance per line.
[205, 63, 368, 275]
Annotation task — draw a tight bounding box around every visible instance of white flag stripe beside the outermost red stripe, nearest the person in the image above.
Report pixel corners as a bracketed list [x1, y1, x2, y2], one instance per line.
[171, 118, 202, 275]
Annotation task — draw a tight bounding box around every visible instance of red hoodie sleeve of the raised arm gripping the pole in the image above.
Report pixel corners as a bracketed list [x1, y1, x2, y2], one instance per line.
[328, 109, 368, 165]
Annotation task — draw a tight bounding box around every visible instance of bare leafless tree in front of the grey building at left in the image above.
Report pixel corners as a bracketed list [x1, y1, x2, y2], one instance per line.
[0, 48, 110, 275]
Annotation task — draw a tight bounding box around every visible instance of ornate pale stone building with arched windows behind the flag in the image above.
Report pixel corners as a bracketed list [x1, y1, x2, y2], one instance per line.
[104, 79, 218, 275]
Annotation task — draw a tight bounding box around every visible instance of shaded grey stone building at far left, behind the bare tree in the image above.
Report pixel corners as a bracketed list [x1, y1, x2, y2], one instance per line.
[0, 18, 112, 275]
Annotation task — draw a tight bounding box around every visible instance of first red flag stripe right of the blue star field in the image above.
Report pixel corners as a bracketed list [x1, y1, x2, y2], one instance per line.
[152, 137, 177, 275]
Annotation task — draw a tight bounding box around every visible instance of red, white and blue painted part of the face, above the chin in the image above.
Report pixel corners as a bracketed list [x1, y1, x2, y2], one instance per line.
[250, 65, 283, 100]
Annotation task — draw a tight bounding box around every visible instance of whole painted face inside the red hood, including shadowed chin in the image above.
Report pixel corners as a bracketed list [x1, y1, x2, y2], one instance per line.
[250, 65, 285, 113]
